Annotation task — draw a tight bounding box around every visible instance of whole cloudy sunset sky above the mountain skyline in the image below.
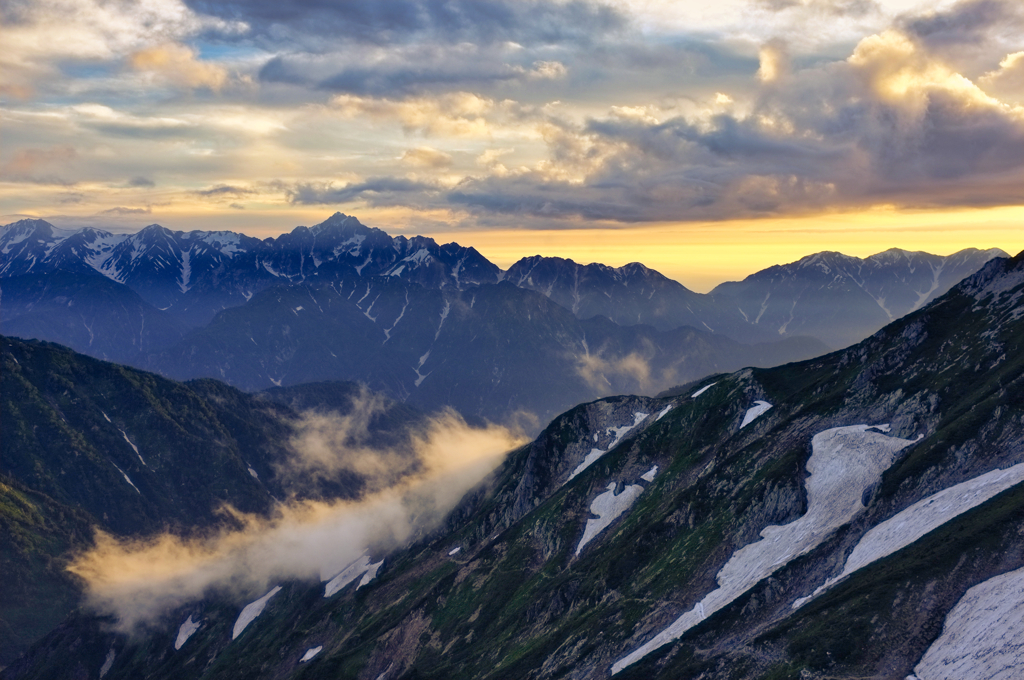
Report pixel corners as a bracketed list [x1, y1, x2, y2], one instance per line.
[0, 0, 1024, 291]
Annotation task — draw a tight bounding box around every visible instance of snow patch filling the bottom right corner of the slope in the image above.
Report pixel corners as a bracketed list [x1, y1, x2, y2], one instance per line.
[908, 561, 1024, 680]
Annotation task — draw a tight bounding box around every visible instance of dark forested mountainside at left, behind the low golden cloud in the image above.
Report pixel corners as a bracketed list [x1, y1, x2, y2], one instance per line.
[0, 338, 423, 665]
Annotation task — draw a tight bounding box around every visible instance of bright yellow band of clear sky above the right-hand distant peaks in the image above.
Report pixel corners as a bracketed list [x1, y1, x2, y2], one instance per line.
[424, 206, 1024, 293]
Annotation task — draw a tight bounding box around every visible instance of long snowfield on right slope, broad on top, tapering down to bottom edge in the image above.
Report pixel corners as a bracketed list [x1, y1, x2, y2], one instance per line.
[611, 421, 913, 675]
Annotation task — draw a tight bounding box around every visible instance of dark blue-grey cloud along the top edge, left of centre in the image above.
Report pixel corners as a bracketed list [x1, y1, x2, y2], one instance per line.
[186, 0, 626, 49]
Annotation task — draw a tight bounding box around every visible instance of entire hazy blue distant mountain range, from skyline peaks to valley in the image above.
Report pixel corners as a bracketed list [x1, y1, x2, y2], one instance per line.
[0, 213, 1006, 432]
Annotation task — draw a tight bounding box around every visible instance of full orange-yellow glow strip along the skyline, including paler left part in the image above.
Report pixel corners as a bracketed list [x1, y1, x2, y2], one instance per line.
[12, 204, 1024, 293]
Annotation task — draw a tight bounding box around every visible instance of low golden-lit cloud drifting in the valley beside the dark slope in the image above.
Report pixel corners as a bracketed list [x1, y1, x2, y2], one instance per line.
[69, 405, 523, 631]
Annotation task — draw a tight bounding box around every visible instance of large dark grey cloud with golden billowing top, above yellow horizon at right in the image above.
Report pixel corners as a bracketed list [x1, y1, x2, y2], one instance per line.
[447, 40, 1024, 222]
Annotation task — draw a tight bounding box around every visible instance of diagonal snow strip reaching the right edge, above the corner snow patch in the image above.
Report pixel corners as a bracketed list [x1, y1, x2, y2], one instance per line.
[793, 463, 1024, 609]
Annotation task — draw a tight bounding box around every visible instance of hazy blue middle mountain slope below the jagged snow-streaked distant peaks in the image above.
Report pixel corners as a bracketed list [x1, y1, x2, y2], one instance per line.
[141, 278, 825, 422]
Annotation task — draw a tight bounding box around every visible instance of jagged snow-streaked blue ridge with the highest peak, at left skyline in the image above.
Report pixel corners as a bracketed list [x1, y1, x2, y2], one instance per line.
[0, 213, 500, 326]
